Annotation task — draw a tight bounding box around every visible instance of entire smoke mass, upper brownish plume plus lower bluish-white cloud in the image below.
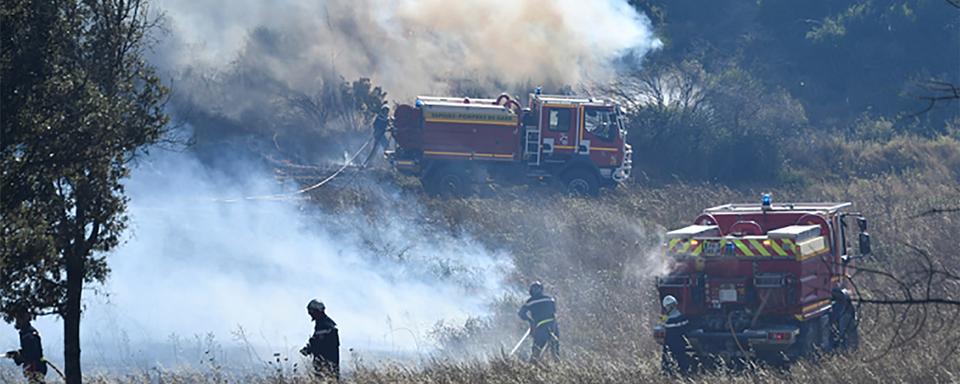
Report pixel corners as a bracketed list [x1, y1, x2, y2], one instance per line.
[1, 0, 660, 370]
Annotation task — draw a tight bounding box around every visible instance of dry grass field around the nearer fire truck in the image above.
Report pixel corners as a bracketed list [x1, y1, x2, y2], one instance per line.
[0, 137, 960, 383]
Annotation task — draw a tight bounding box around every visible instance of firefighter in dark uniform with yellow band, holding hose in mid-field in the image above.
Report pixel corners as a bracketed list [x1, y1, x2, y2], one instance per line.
[519, 281, 560, 361]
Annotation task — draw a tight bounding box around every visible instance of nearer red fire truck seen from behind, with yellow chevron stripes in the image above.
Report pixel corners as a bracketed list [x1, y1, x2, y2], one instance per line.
[654, 195, 870, 364]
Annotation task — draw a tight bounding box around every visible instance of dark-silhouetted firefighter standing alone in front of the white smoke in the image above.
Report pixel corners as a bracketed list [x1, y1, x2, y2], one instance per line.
[300, 300, 340, 379]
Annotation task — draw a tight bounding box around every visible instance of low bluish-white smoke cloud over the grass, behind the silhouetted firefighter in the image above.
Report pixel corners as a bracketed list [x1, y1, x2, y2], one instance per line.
[2, 151, 511, 371]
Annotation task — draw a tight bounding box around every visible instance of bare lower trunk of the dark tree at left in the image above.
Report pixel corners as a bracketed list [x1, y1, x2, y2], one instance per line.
[63, 254, 83, 384]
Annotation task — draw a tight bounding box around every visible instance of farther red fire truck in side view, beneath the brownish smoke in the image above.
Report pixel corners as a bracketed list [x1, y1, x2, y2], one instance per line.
[387, 92, 632, 195]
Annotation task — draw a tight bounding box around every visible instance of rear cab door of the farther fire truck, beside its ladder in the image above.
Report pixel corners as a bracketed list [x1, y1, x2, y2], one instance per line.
[540, 104, 578, 163]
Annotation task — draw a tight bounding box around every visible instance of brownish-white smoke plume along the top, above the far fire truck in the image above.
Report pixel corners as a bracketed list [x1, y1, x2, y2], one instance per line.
[155, 0, 661, 99]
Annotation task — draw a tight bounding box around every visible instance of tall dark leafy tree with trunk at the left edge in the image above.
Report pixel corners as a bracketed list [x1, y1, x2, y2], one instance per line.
[0, 0, 168, 383]
